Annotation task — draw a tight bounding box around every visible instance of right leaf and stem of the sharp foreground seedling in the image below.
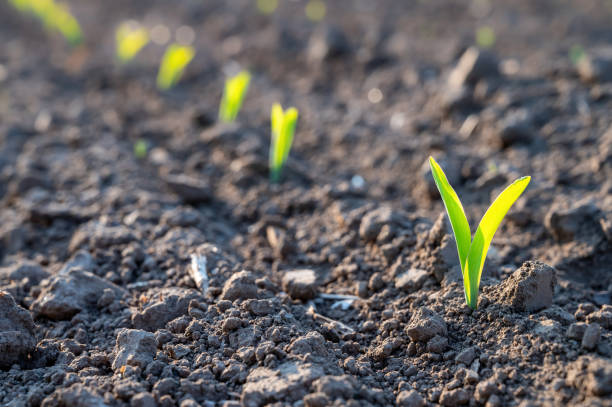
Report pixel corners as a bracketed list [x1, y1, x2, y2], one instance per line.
[463, 177, 531, 309]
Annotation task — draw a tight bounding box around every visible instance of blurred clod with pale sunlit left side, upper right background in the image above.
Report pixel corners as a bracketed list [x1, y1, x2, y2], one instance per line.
[448, 47, 500, 88]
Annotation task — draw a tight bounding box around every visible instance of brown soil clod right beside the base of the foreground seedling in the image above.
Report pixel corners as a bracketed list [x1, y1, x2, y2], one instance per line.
[501, 261, 556, 312]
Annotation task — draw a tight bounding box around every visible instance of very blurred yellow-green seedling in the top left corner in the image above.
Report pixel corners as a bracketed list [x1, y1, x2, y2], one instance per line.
[9, 0, 83, 46]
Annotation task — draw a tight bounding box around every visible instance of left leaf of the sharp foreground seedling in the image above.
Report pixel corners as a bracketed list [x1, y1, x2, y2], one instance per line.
[429, 157, 472, 273]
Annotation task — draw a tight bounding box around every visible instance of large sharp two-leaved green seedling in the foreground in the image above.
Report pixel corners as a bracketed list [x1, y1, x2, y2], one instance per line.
[429, 157, 531, 309]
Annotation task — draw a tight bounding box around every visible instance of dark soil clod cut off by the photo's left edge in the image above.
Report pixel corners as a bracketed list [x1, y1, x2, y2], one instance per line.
[0, 291, 36, 369]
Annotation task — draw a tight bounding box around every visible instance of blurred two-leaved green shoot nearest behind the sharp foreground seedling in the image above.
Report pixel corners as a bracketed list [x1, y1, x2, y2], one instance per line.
[270, 103, 298, 183]
